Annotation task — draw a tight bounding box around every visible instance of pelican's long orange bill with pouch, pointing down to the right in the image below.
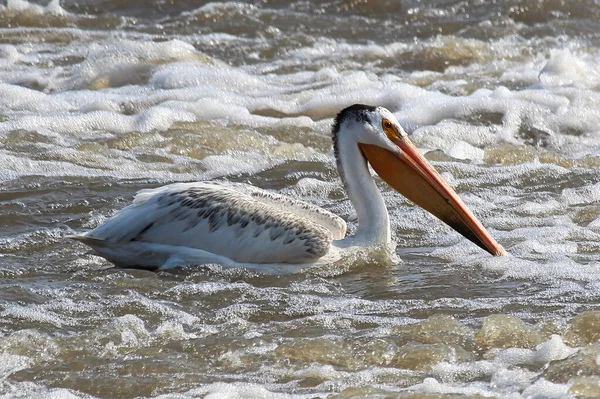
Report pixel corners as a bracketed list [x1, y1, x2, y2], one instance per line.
[359, 137, 506, 256]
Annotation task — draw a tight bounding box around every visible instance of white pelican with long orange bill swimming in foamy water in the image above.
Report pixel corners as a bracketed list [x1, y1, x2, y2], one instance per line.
[71, 104, 505, 270]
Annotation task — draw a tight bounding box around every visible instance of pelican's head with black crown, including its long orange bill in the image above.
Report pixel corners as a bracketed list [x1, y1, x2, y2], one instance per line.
[333, 104, 506, 255]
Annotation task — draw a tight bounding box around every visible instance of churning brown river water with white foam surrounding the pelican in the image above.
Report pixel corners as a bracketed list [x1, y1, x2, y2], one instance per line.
[0, 0, 600, 398]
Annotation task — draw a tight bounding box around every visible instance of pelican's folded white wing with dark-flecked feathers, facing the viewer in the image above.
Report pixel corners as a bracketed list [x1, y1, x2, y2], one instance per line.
[86, 182, 345, 263]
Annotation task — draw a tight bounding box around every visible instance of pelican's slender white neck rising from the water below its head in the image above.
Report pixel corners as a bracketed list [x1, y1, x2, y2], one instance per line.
[336, 139, 391, 245]
